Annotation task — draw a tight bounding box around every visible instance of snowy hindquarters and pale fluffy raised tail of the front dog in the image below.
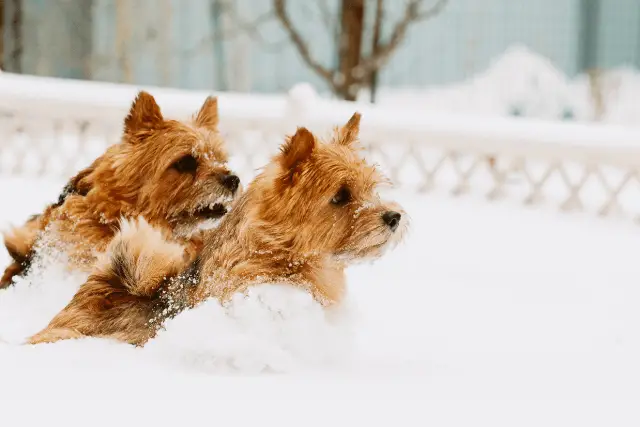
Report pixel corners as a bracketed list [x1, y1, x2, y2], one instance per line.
[28, 219, 187, 345]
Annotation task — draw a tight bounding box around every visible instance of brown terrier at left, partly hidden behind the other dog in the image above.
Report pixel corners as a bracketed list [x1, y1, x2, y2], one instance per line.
[0, 92, 240, 288]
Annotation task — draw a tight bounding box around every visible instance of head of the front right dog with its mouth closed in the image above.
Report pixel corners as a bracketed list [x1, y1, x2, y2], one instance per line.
[247, 113, 407, 262]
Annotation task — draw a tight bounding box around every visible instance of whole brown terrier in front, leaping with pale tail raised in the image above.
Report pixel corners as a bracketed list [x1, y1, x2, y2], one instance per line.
[29, 113, 406, 345]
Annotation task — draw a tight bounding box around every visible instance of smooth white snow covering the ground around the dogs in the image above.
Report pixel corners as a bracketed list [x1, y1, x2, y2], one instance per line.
[0, 180, 640, 427]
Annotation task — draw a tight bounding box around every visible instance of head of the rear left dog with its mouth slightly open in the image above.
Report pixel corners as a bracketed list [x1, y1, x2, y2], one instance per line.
[76, 92, 241, 234]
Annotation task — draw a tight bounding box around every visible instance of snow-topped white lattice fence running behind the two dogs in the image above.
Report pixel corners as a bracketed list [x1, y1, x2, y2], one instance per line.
[0, 73, 640, 221]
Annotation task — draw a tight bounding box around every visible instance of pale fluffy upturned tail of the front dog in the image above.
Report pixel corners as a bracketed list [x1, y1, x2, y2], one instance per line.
[98, 218, 187, 297]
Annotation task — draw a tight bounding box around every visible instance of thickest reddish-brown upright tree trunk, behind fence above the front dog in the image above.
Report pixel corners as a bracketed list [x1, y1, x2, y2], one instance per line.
[336, 0, 364, 101]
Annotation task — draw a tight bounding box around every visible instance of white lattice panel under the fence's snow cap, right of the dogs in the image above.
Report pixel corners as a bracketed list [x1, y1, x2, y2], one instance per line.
[370, 144, 640, 220]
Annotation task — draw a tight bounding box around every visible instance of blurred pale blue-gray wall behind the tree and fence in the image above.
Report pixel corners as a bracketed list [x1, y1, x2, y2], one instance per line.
[5, 0, 640, 92]
